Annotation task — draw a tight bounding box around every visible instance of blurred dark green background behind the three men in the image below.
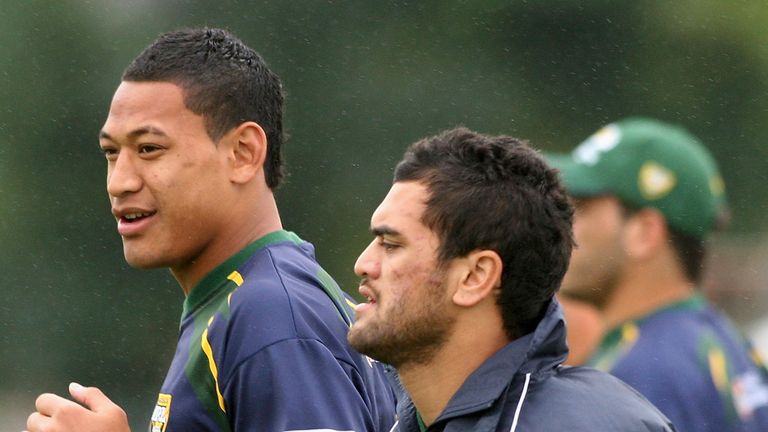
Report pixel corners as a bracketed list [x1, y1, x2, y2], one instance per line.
[0, 0, 768, 431]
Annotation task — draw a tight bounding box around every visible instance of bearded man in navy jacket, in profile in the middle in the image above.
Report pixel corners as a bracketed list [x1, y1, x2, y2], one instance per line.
[349, 128, 674, 432]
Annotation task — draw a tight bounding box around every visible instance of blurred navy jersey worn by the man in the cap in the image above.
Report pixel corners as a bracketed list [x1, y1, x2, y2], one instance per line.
[589, 295, 768, 432]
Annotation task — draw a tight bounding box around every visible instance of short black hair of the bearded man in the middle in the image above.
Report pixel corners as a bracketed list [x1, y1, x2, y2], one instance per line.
[394, 128, 573, 339]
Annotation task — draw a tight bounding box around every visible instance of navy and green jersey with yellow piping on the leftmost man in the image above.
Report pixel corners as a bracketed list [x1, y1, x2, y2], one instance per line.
[150, 231, 395, 432]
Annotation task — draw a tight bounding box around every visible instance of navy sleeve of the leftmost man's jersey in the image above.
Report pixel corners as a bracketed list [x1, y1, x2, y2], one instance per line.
[222, 339, 375, 432]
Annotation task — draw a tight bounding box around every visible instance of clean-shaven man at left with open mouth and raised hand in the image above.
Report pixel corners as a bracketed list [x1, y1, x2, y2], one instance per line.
[27, 29, 394, 432]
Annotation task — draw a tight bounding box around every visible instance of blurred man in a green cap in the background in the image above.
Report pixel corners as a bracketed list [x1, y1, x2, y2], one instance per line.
[551, 118, 768, 432]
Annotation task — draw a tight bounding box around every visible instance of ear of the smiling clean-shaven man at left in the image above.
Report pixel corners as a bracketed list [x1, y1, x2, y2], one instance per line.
[227, 121, 267, 183]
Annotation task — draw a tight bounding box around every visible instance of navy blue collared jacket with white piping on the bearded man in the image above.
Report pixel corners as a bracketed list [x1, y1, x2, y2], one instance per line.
[393, 300, 675, 432]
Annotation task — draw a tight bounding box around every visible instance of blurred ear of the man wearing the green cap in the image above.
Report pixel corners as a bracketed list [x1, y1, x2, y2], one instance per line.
[625, 208, 669, 260]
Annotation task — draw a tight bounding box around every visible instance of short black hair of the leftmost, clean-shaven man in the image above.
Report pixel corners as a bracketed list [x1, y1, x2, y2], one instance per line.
[122, 28, 284, 189]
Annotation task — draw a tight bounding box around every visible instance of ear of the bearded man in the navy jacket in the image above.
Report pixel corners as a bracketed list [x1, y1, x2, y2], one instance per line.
[453, 249, 503, 307]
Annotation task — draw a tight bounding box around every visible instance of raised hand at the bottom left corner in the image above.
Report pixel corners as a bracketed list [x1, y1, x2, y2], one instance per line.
[27, 383, 130, 432]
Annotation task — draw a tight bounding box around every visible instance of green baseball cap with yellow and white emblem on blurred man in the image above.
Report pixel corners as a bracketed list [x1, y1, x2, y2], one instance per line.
[546, 117, 727, 238]
